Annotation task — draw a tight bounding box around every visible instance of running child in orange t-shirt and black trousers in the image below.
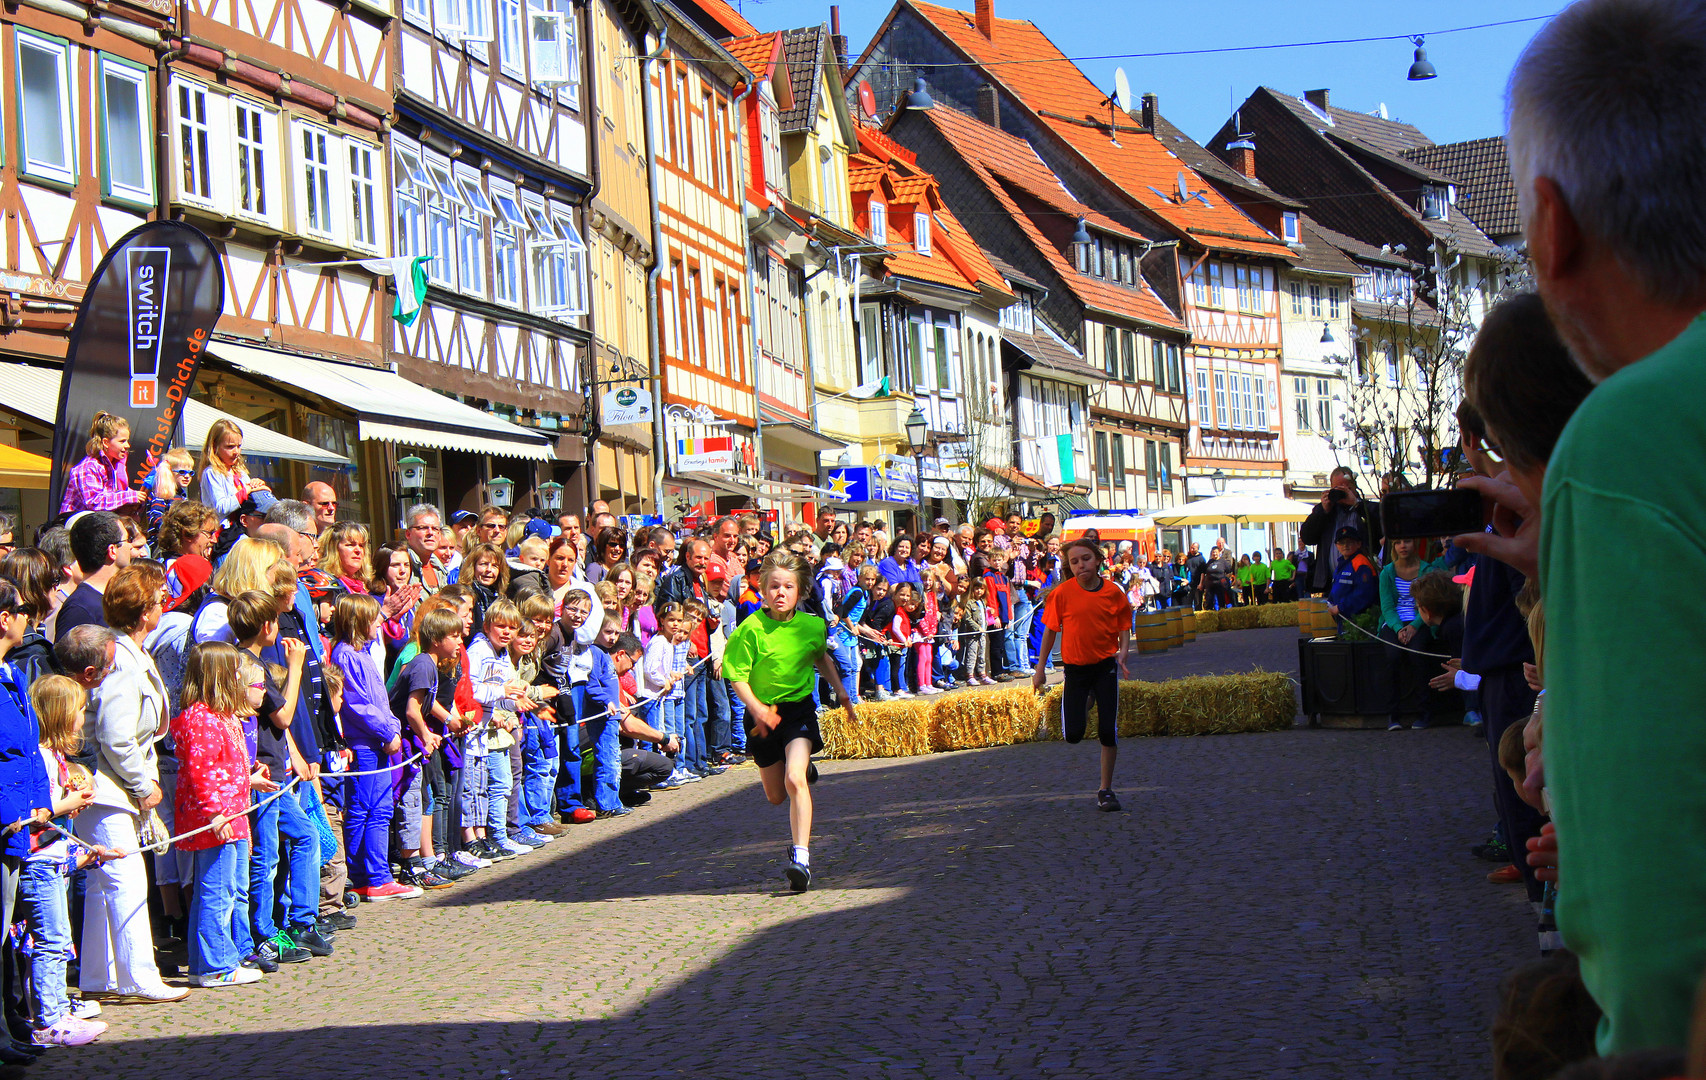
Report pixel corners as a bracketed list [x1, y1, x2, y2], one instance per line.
[1030, 539, 1131, 810]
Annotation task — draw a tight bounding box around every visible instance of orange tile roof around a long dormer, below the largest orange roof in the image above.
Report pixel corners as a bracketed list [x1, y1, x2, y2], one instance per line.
[923, 102, 1182, 329]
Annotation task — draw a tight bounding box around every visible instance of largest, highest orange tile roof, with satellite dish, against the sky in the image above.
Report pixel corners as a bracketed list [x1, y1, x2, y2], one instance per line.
[902, 0, 1290, 259]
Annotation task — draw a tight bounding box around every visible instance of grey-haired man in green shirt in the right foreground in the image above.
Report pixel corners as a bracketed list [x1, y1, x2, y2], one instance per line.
[1457, 0, 1706, 1054]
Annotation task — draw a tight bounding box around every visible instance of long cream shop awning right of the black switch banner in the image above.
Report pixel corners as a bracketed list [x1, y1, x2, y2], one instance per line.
[208, 341, 556, 461]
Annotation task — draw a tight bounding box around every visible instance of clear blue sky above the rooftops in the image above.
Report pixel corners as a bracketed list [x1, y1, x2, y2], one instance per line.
[730, 0, 1563, 143]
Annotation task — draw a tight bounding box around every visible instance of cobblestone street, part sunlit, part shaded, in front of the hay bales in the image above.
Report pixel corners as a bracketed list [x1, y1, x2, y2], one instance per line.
[60, 682, 1534, 1080]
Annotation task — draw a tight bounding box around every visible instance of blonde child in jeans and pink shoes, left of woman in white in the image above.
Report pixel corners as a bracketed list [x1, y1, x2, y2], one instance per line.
[17, 676, 106, 1046]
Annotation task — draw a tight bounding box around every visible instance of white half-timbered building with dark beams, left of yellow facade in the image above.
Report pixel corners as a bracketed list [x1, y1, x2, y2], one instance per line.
[389, 0, 595, 508]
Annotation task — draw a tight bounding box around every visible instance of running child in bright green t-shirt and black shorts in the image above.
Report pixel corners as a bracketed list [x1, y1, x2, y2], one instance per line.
[723, 551, 858, 892]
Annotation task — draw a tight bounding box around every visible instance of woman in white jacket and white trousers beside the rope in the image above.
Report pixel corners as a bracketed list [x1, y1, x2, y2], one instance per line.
[77, 563, 189, 1002]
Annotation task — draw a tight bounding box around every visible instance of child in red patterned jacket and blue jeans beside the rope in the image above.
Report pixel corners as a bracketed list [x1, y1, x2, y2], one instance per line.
[172, 642, 267, 990]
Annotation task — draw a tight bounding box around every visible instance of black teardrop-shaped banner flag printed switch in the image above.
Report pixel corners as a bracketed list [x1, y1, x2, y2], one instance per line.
[48, 222, 225, 507]
